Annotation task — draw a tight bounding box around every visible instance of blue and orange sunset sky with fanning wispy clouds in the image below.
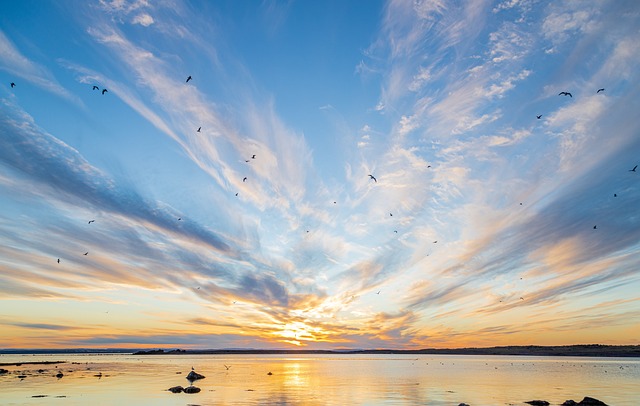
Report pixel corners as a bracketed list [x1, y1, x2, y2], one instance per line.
[0, 0, 640, 349]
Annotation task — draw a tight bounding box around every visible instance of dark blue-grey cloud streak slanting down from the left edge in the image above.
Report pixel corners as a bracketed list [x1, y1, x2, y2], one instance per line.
[0, 101, 233, 255]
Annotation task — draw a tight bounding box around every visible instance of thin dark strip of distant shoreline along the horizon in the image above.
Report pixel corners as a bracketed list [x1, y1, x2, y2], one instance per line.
[0, 344, 640, 357]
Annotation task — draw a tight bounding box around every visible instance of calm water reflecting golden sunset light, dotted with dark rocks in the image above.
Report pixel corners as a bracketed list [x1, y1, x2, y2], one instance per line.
[0, 354, 640, 406]
